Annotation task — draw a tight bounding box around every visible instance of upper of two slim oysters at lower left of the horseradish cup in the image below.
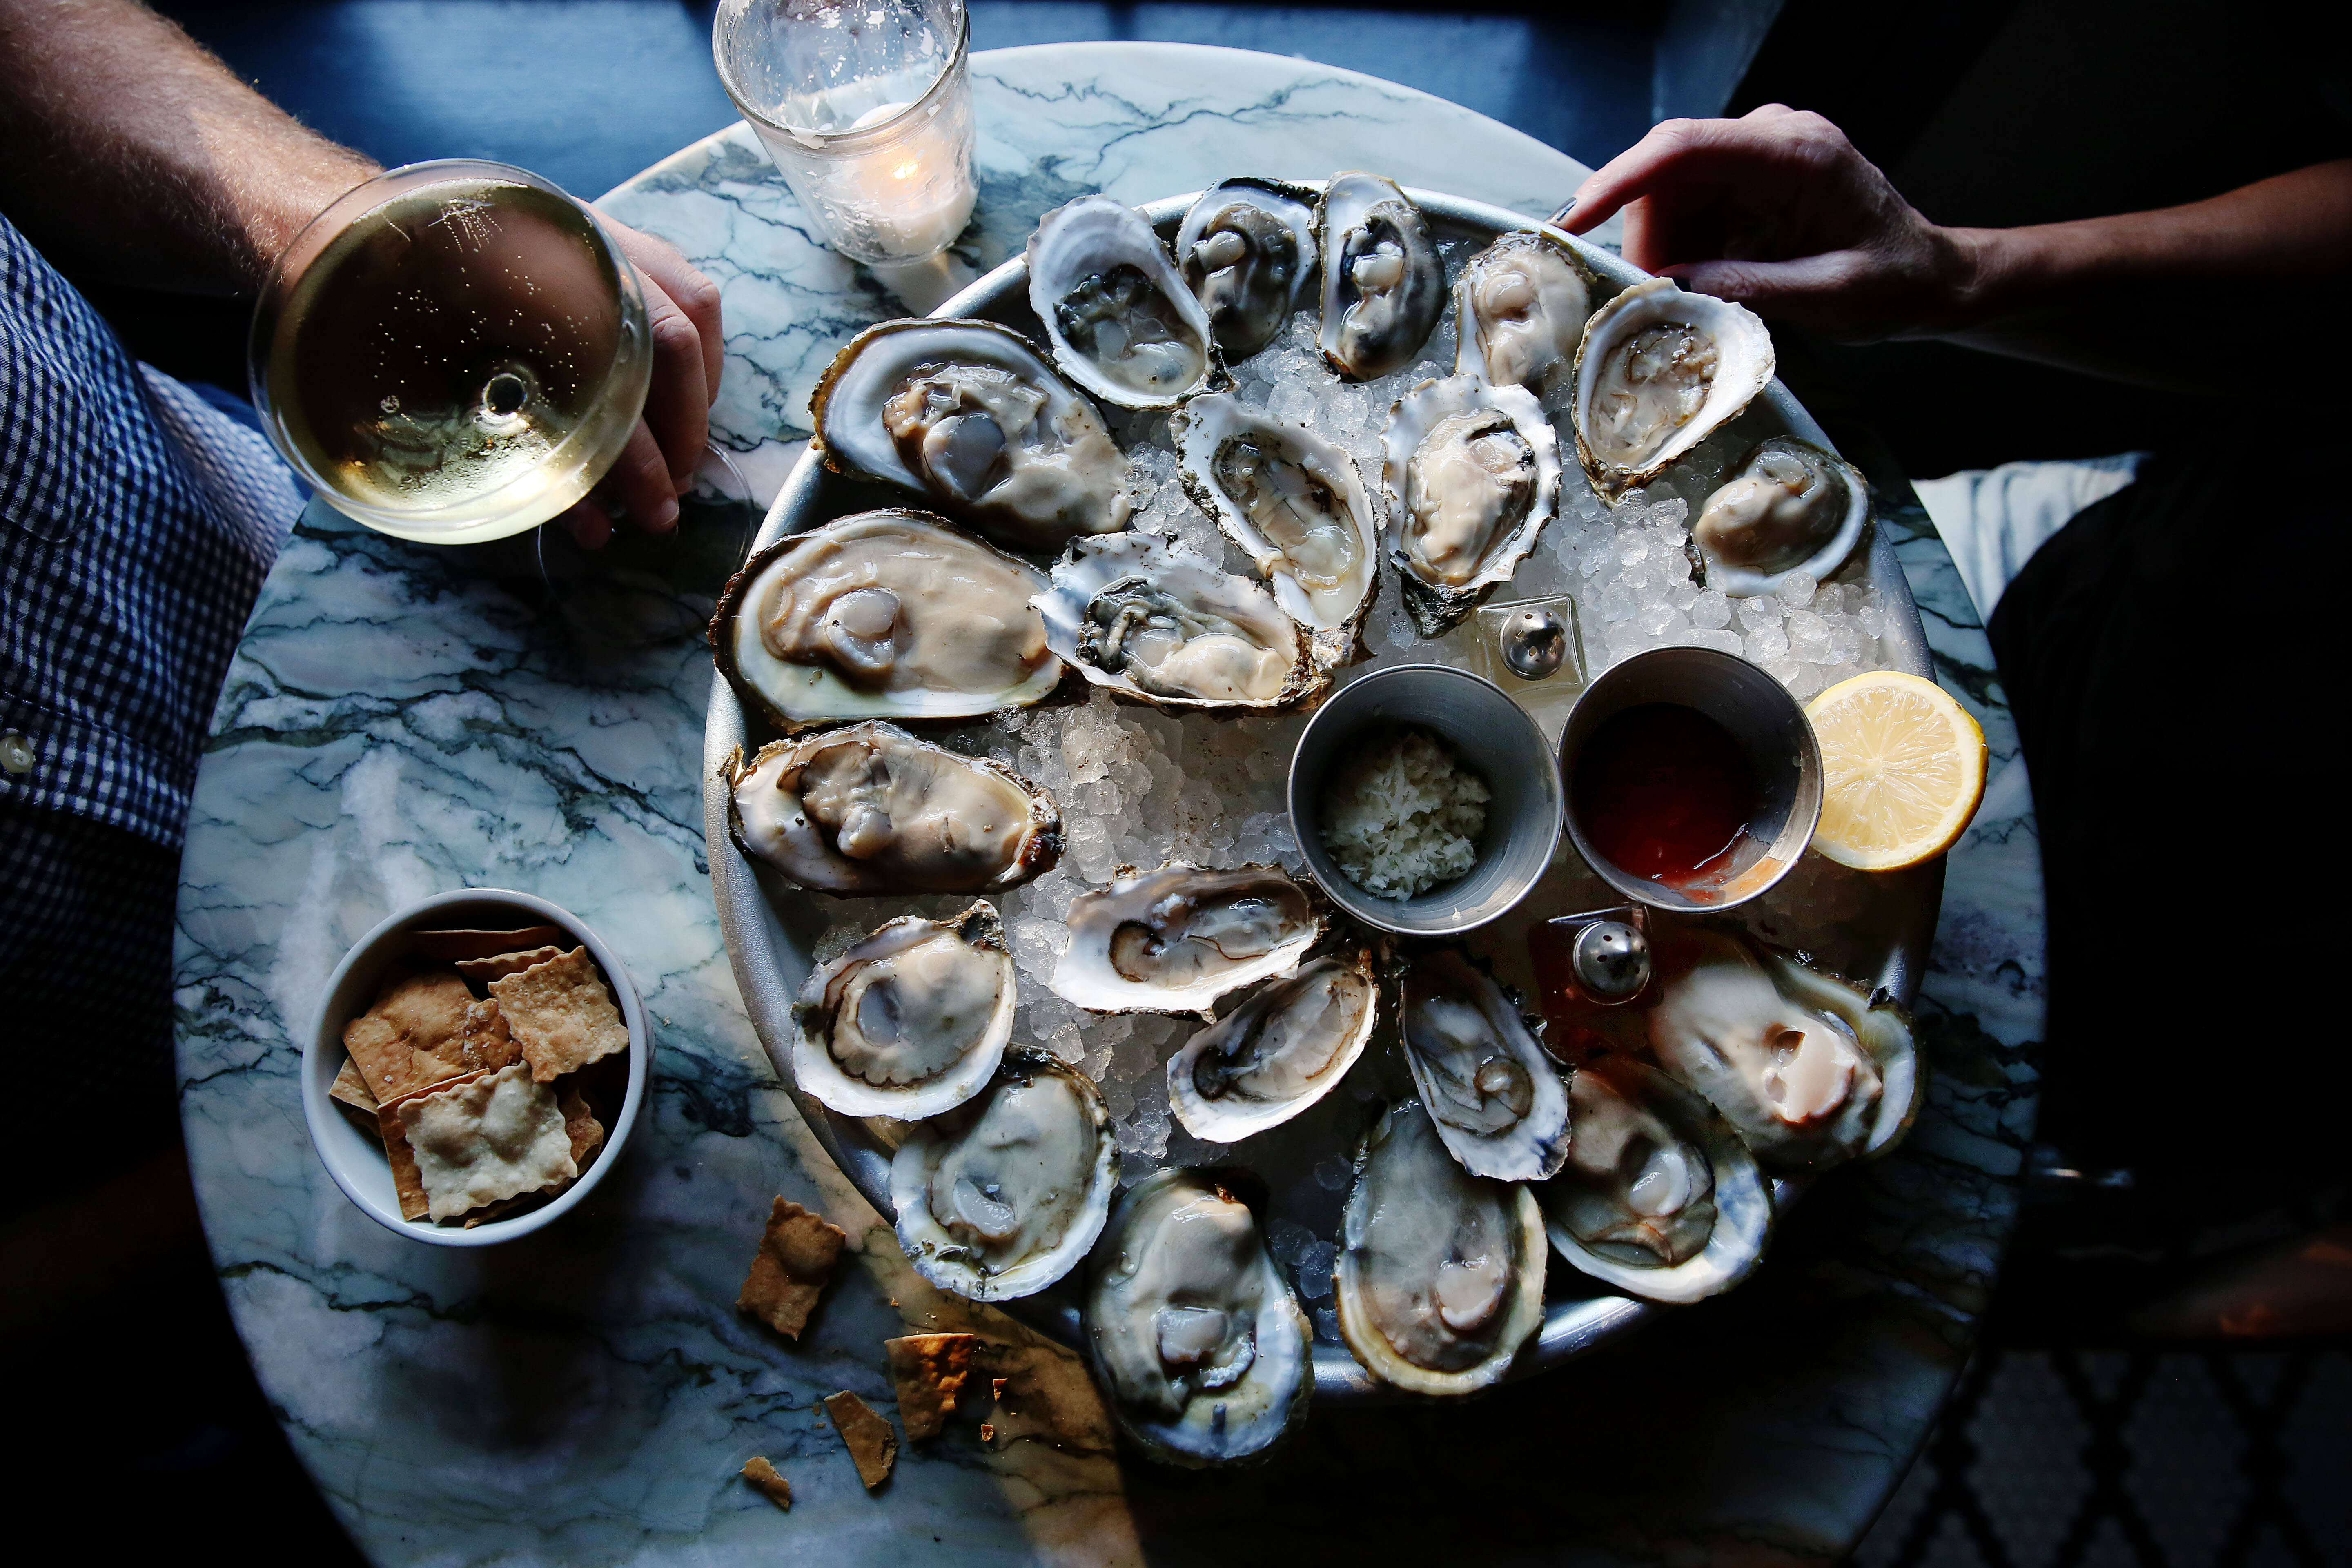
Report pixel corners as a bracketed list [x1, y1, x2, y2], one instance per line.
[1049, 860, 1324, 1013]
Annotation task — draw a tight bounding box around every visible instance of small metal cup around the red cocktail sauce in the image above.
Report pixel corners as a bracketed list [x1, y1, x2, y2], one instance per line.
[1559, 649, 1820, 915]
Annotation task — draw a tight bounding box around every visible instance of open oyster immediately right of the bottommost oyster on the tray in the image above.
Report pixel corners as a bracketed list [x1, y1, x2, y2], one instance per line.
[1334, 1100, 1543, 1394]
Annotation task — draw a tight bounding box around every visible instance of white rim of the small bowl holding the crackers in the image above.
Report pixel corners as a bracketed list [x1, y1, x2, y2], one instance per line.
[301, 889, 649, 1246]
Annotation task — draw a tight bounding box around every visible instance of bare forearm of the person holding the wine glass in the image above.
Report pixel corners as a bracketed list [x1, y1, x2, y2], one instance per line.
[0, 0, 374, 294]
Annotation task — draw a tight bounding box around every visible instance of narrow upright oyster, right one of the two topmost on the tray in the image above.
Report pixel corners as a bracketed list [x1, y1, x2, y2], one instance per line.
[1317, 174, 1446, 381]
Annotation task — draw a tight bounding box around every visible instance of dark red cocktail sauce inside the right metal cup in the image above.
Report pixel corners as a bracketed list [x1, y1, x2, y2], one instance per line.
[1569, 703, 1757, 889]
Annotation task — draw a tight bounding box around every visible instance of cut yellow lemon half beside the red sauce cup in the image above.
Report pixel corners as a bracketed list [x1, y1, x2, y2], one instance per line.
[1804, 670, 1985, 872]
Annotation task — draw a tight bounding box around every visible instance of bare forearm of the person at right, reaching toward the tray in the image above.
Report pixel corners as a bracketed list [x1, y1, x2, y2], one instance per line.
[1933, 160, 2352, 397]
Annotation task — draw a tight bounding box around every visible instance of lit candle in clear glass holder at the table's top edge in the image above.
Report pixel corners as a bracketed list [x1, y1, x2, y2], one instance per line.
[710, 0, 976, 266]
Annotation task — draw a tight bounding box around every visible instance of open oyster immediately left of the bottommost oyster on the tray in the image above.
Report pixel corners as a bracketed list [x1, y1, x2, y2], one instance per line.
[889, 1046, 1120, 1302]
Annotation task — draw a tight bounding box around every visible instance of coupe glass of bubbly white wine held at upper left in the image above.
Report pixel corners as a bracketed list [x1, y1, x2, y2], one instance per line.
[247, 158, 654, 546]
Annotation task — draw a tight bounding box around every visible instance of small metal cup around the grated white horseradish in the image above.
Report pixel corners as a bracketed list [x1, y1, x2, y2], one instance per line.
[1289, 665, 1559, 935]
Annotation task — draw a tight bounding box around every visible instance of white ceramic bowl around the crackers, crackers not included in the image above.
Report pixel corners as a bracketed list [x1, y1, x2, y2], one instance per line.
[301, 889, 654, 1246]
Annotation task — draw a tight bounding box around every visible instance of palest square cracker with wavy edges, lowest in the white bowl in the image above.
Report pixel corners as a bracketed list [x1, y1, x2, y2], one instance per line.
[397, 1062, 579, 1220]
